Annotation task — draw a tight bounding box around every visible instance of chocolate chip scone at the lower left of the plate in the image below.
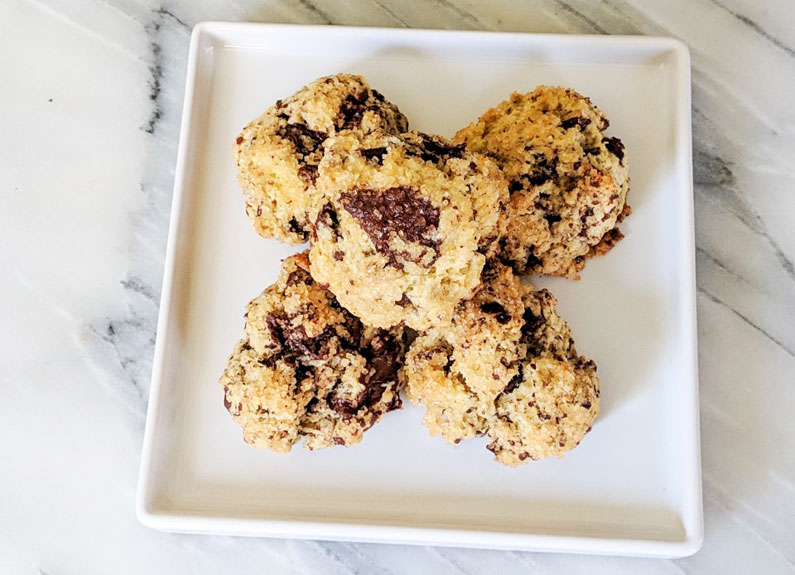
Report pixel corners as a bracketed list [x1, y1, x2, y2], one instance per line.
[220, 253, 405, 453]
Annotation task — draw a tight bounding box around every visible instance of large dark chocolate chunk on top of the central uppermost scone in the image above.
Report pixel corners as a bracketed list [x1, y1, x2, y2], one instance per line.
[341, 186, 441, 268]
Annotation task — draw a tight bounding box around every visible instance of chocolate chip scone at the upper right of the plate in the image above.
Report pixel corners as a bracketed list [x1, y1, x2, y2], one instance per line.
[454, 86, 630, 279]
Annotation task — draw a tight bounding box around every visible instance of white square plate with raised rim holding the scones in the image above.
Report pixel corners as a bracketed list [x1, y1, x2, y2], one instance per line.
[138, 23, 702, 556]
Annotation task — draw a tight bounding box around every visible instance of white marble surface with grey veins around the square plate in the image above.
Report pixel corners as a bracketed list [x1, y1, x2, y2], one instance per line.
[0, 0, 795, 575]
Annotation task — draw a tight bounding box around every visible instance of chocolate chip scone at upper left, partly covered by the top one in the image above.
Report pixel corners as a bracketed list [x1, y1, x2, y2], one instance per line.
[234, 74, 408, 244]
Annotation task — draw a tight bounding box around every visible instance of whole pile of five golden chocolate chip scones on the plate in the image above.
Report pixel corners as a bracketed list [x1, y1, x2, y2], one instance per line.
[220, 75, 629, 465]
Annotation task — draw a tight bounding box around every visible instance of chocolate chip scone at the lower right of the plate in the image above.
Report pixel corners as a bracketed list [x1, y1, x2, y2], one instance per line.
[403, 264, 599, 466]
